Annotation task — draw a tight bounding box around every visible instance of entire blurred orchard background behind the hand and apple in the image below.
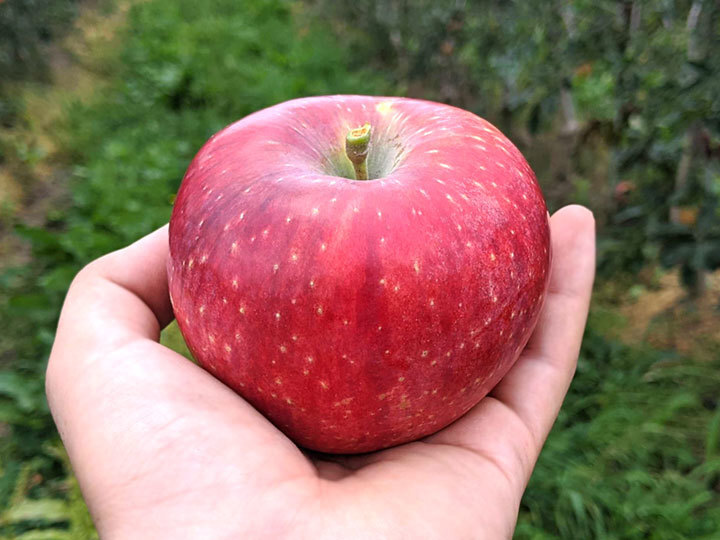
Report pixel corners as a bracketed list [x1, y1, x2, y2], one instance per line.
[0, 0, 720, 540]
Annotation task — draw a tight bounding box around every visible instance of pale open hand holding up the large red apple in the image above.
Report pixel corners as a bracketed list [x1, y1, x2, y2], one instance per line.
[46, 206, 595, 540]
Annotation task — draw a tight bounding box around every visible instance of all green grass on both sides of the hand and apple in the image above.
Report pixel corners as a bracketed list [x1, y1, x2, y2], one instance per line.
[0, 0, 720, 540]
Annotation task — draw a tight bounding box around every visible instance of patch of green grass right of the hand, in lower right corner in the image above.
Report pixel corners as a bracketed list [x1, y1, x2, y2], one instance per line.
[516, 314, 720, 540]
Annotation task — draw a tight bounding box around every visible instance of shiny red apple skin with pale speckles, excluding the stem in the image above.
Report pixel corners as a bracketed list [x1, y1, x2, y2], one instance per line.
[168, 96, 551, 453]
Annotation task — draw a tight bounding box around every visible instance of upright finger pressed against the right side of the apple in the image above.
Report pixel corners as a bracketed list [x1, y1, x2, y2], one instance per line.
[427, 206, 595, 491]
